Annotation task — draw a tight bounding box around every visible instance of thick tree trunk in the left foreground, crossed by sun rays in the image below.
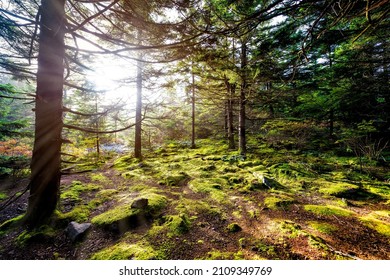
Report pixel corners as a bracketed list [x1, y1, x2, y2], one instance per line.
[25, 0, 65, 228]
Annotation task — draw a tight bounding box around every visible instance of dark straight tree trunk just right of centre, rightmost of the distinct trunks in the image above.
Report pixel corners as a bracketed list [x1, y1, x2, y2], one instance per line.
[238, 40, 248, 156]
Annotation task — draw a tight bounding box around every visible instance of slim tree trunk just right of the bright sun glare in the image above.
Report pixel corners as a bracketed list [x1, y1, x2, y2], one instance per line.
[134, 30, 143, 159]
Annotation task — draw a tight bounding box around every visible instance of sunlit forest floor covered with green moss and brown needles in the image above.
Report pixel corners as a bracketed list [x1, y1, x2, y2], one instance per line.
[0, 141, 390, 260]
